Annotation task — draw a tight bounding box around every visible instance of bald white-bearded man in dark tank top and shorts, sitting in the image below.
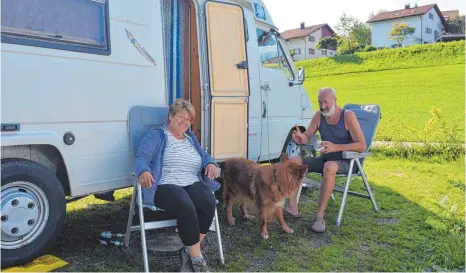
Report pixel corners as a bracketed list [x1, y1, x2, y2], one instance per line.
[285, 88, 366, 232]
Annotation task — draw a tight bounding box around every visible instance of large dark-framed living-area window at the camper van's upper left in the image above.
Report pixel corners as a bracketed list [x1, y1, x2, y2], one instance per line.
[1, 0, 110, 55]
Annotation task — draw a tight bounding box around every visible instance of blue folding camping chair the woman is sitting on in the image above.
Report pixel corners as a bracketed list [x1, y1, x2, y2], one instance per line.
[124, 106, 225, 272]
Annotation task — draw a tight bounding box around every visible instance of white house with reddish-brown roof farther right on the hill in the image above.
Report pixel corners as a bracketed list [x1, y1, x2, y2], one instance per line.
[367, 4, 445, 47]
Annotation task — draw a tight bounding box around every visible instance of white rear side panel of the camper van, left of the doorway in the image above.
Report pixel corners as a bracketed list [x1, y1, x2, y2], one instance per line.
[1, 0, 167, 196]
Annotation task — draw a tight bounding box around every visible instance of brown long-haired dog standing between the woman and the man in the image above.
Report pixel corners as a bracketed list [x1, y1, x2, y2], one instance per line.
[222, 154, 307, 239]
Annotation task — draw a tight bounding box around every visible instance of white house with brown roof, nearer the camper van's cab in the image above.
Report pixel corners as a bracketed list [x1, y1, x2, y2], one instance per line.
[281, 22, 336, 61]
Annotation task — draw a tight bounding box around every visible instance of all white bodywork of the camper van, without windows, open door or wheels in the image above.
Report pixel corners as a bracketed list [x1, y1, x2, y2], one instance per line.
[1, 0, 313, 196]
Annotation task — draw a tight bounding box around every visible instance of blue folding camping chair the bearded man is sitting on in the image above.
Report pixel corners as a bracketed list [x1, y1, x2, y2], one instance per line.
[297, 104, 381, 226]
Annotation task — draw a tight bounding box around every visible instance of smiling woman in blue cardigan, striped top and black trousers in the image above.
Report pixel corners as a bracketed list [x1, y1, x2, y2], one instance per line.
[135, 99, 218, 271]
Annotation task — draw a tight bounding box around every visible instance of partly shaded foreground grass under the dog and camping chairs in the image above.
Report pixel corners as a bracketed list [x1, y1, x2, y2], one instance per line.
[52, 156, 465, 271]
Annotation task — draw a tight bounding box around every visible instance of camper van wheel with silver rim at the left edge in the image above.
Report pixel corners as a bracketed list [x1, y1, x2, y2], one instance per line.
[1, 159, 66, 268]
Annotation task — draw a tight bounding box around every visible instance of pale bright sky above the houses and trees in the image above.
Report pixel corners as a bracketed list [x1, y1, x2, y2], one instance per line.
[262, 0, 466, 32]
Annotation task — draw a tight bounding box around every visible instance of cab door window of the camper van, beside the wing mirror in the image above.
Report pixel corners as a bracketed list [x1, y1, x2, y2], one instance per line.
[257, 29, 294, 81]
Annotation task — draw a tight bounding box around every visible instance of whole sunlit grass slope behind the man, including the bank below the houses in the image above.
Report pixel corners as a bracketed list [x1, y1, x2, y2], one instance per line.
[296, 41, 465, 142]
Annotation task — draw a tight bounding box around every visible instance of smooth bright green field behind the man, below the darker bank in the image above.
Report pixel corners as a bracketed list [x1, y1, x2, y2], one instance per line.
[305, 64, 465, 141]
